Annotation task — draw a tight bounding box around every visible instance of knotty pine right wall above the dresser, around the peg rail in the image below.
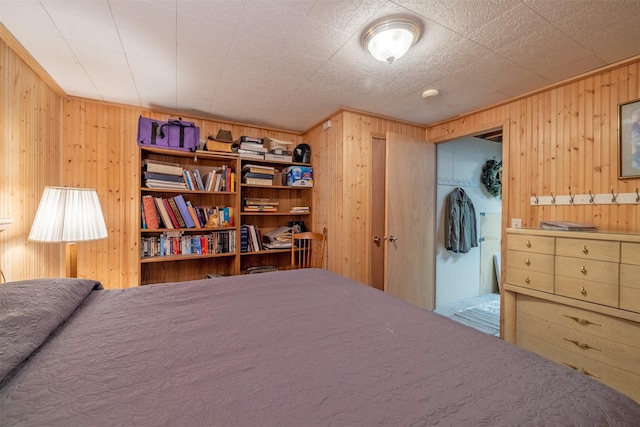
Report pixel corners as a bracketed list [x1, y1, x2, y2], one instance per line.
[427, 57, 640, 233]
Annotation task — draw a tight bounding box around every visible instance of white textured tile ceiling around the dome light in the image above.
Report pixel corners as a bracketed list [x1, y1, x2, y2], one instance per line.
[0, 0, 640, 131]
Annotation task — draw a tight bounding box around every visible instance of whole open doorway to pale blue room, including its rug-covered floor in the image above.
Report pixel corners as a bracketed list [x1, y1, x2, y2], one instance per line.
[435, 128, 503, 336]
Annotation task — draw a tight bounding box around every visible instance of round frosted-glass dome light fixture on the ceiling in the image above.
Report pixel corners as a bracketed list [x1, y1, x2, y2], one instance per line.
[362, 16, 422, 64]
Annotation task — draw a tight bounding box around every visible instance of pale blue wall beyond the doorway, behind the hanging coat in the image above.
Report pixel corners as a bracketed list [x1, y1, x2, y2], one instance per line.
[436, 136, 502, 314]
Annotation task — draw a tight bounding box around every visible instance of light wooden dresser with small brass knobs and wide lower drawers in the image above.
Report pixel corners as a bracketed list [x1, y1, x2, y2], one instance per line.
[502, 229, 640, 402]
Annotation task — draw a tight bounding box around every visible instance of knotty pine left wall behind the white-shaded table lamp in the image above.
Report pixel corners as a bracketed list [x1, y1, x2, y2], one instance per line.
[0, 24, 64, 281]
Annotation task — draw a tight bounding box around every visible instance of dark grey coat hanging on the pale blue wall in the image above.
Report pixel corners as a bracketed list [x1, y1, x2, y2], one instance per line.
[444, 187, 478, 253]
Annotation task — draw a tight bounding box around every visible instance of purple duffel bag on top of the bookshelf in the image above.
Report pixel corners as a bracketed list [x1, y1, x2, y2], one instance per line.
[138, 116, 200, 151]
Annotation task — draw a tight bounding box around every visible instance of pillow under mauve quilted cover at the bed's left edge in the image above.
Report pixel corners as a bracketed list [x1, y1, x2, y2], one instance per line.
[0, 279, 102, 384]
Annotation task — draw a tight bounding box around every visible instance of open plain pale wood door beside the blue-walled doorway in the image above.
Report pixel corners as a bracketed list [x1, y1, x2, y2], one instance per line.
[385, 132, 436, 310]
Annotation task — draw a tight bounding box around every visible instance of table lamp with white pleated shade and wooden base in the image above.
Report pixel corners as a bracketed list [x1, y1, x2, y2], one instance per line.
[29, 187, 107, 277]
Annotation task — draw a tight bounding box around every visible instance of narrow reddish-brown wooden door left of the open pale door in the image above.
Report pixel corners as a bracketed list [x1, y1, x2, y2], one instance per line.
[369, 137, 387, 291]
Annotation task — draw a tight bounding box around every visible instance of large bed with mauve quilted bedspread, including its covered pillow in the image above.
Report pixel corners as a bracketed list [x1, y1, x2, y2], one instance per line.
[0, 269, 640, 427]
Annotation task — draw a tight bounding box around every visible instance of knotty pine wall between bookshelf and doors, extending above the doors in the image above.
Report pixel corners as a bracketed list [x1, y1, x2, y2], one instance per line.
[304, 109, 425, 283]
